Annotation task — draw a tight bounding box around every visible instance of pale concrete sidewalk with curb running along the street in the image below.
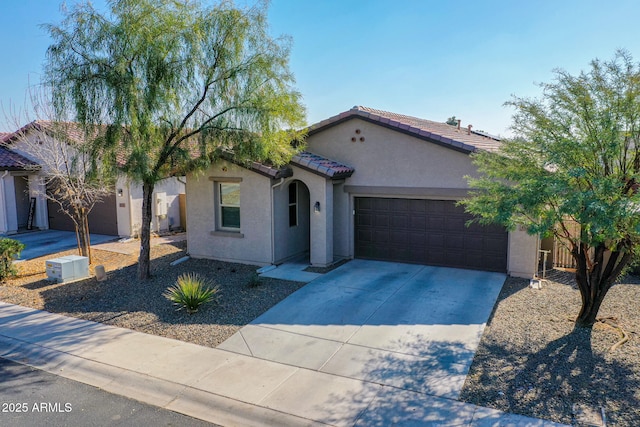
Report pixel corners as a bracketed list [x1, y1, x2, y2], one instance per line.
[0, 302, 559, 426]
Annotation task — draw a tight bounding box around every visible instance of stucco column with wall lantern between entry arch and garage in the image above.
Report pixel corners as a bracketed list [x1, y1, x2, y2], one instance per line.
[309, 180, 333, 267]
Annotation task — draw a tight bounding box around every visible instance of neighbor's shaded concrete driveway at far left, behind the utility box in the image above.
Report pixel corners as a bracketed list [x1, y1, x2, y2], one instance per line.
[7, 230, 118, 260]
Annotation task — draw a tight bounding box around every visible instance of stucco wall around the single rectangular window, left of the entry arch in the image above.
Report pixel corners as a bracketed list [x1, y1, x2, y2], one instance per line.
[186, 162, 272, 265]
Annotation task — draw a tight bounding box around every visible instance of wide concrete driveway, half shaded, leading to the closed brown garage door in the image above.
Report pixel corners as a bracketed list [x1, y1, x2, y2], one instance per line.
[218, 260, 506, 399]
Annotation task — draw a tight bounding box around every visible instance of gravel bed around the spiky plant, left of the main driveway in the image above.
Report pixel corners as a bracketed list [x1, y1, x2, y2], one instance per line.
[0, 242, 304, 347]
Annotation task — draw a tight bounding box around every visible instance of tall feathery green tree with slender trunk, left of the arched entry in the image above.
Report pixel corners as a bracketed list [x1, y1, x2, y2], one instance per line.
[45, 0, 304, 279]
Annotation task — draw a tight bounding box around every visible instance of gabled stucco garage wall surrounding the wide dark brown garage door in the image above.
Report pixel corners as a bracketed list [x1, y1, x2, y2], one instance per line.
[307, 118, 538, 278]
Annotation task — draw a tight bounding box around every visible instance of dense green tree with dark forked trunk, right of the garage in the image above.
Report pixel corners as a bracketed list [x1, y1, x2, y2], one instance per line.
[464, 51, 640, 327]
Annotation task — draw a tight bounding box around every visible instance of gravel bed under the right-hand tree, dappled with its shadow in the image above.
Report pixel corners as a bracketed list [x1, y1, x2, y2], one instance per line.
[461, 272, 640, 426]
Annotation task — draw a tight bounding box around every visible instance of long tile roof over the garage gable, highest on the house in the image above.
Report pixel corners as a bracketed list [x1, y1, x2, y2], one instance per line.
[308, 106, 500, 153]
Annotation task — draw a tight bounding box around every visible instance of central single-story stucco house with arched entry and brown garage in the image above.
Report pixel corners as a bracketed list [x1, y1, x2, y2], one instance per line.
[187, 107, 538, 277]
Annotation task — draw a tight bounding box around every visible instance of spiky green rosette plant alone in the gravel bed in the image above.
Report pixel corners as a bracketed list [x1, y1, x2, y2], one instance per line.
[163, 273, 220, 314]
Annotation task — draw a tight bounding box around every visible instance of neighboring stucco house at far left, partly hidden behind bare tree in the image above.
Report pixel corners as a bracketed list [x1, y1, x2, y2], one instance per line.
[0, 120, 185, 237]
